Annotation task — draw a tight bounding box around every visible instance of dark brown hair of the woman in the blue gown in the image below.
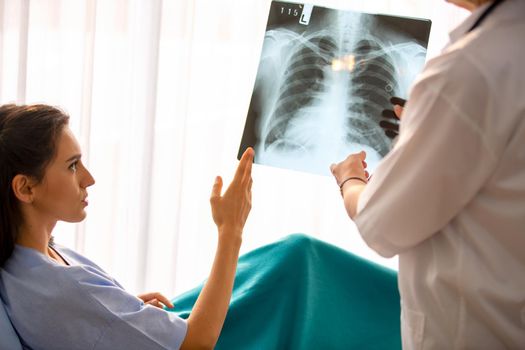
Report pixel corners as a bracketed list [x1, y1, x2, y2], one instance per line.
[0, 104, 69, 267]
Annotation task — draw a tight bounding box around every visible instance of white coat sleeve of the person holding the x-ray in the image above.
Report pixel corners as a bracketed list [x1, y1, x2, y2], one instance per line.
[355, 55, 497, 257]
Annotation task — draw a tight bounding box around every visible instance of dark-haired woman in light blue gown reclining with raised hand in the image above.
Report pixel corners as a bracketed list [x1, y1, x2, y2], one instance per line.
[0, 105, 254, 349]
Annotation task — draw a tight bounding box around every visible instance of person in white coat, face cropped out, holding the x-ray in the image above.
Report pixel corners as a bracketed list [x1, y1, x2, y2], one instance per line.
[331, 0, 525, 349]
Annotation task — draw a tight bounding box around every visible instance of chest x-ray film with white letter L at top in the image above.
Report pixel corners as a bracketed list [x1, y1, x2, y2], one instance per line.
[239, 1, 430, 175]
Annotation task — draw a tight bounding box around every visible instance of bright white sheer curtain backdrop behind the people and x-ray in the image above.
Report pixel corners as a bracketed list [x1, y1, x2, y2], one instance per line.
[0, 0, 468, 295]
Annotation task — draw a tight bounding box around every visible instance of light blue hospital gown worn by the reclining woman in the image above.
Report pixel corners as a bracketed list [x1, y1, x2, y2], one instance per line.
[0, 246, 187, 350]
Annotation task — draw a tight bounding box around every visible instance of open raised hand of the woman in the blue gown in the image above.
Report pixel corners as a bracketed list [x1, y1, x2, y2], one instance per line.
[210, 148, 255, 238]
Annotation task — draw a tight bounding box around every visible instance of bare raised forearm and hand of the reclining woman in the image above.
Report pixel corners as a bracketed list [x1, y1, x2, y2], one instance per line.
[181, 148, 254, 349]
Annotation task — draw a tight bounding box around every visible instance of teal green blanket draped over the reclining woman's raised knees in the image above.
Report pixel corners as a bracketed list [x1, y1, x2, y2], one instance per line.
[173, 234, 401, 350]
